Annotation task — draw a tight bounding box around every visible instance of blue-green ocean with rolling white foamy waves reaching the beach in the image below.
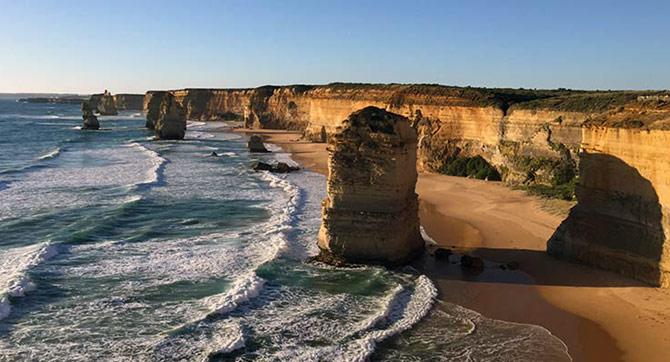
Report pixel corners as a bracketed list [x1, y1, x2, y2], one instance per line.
[0, 99, 570, 361]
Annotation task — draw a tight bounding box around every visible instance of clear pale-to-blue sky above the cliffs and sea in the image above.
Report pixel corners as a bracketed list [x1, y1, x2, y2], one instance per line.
[0, 0, 670, 94]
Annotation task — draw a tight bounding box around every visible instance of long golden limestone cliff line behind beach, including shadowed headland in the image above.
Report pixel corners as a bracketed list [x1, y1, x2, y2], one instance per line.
[145, 84, 670, 285]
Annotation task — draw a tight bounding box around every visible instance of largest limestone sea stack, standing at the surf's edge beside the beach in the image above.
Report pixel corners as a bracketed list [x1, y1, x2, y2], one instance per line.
[318, 107, 424, 265]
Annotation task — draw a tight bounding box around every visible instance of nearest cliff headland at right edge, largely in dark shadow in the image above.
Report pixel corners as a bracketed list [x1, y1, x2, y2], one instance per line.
[547, 127, 670, 287]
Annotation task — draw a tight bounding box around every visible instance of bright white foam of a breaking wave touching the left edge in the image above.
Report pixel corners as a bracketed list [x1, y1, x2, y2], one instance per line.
[0, 243, 58, 319]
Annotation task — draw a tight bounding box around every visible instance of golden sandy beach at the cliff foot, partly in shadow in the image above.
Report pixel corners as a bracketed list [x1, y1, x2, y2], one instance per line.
[245, 130, 670, 361]
